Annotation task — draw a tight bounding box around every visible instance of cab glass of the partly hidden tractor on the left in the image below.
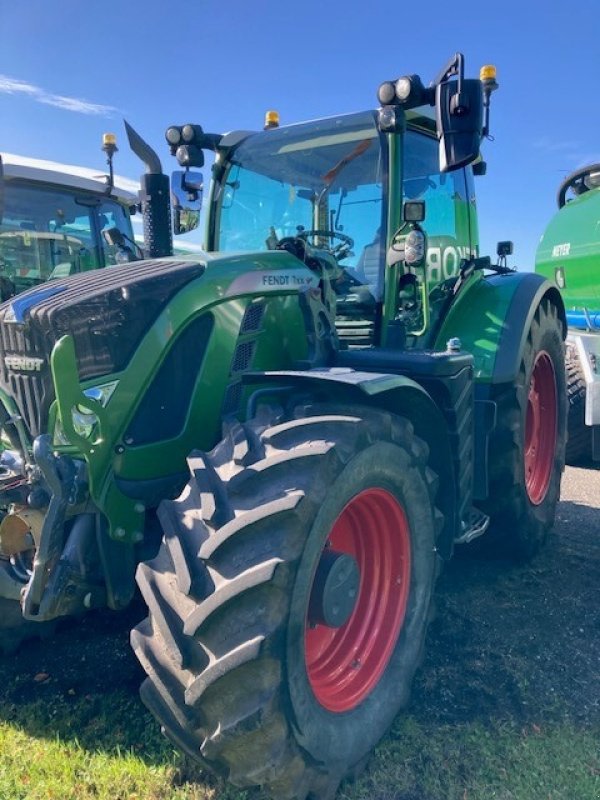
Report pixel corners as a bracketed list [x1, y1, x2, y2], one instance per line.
[0, 181, 133, 300]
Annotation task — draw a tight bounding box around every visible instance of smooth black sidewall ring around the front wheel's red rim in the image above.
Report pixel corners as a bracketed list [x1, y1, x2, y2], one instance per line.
[287, 442, 436, 769]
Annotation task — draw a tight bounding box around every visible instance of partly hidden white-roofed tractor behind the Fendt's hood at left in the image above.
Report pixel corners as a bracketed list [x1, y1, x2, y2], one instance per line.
[0, 134, 143, 300]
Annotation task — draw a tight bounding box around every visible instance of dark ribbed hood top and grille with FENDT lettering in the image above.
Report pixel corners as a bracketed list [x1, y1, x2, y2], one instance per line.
[0, 251, 319, 438]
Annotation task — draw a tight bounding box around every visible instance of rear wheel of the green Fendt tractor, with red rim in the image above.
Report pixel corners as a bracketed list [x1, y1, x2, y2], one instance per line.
[484, 299, 567, 560]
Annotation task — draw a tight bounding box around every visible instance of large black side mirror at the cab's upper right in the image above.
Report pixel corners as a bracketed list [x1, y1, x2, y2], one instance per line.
[435, 79, 483, 172]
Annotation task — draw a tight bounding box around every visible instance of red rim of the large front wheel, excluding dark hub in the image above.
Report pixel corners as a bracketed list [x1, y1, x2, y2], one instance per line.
[304, 489, 411, 713]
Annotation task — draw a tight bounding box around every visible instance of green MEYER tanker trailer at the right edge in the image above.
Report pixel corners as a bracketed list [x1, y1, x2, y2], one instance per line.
[536, 164, 600, 463]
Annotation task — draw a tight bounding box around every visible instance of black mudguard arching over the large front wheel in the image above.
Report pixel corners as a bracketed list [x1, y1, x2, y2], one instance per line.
[243, 367, 458, 559]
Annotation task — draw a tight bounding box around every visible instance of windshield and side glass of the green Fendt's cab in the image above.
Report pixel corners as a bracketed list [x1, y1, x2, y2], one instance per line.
[207, 111, 477, 348]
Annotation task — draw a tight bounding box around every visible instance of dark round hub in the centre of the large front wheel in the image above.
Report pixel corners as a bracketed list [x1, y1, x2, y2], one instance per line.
[308, 549, 360, 628]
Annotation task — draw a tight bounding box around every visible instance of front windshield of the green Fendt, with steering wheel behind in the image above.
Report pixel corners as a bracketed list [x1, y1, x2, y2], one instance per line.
[215, 112, 385, 290]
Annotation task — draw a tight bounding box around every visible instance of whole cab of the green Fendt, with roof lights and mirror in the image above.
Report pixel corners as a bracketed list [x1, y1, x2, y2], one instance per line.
[167, 54, 497, 349]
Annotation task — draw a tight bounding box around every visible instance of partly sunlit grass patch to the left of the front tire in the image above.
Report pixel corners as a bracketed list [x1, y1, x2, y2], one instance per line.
[0, 684, 245, 800]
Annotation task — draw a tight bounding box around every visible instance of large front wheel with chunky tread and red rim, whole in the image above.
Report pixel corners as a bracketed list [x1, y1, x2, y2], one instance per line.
[132, 406, 441, 800]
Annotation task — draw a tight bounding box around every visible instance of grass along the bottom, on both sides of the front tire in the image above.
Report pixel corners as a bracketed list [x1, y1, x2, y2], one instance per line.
[0, 684, 600, 800]
